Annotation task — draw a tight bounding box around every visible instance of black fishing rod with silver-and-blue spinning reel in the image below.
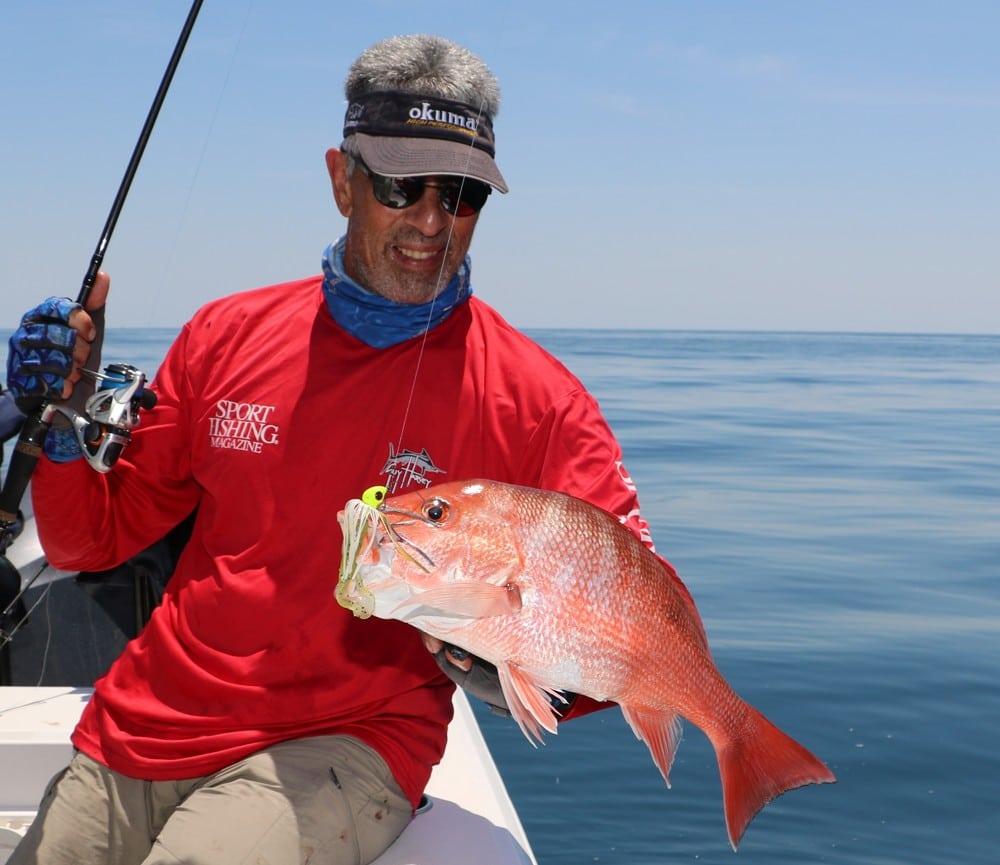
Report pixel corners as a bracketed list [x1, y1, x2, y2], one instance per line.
[0, 0, 203, 648]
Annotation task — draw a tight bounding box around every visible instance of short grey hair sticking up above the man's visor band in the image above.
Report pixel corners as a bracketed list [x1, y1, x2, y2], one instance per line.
[344, 34, 500, 120]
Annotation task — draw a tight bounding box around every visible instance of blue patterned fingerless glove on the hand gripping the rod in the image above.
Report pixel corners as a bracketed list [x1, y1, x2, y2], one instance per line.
[7, 297, 104, 462]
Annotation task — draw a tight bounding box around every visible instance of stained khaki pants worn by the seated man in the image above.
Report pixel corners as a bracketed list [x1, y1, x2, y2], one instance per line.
[8, 736, 412, 865]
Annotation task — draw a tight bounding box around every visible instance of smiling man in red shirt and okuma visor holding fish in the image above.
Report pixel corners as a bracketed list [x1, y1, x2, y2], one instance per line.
[5, 36, 664, 865]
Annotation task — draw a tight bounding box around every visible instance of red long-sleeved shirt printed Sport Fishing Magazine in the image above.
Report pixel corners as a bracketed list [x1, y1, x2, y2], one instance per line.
[33, 277, 664, 804]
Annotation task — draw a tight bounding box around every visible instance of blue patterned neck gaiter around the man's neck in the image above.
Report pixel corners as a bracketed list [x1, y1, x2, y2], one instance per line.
[323, 237, 472, 348]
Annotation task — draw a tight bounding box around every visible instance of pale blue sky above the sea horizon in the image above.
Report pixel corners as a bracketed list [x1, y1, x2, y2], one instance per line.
[0, 0, 1000, 333]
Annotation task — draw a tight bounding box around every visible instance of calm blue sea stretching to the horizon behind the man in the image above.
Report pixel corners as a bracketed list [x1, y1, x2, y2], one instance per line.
[1, 331, 1000, 865]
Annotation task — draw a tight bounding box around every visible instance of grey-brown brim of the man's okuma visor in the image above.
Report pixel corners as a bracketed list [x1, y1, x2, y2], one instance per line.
[354, 132, 507, 192]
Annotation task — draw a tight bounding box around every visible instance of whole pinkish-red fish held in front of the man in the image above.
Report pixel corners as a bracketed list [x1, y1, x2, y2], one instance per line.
[334, 480, 836, 851]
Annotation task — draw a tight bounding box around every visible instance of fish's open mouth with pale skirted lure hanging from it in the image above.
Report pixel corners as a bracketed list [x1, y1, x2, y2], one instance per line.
[334, 499, 434, 619]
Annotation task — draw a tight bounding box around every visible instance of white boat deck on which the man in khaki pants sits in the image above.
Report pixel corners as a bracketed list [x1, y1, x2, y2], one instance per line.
[0, 687, 536, 865]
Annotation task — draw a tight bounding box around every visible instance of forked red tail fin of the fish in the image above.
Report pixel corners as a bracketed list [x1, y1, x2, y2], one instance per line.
[713, 706, 837, 850]
